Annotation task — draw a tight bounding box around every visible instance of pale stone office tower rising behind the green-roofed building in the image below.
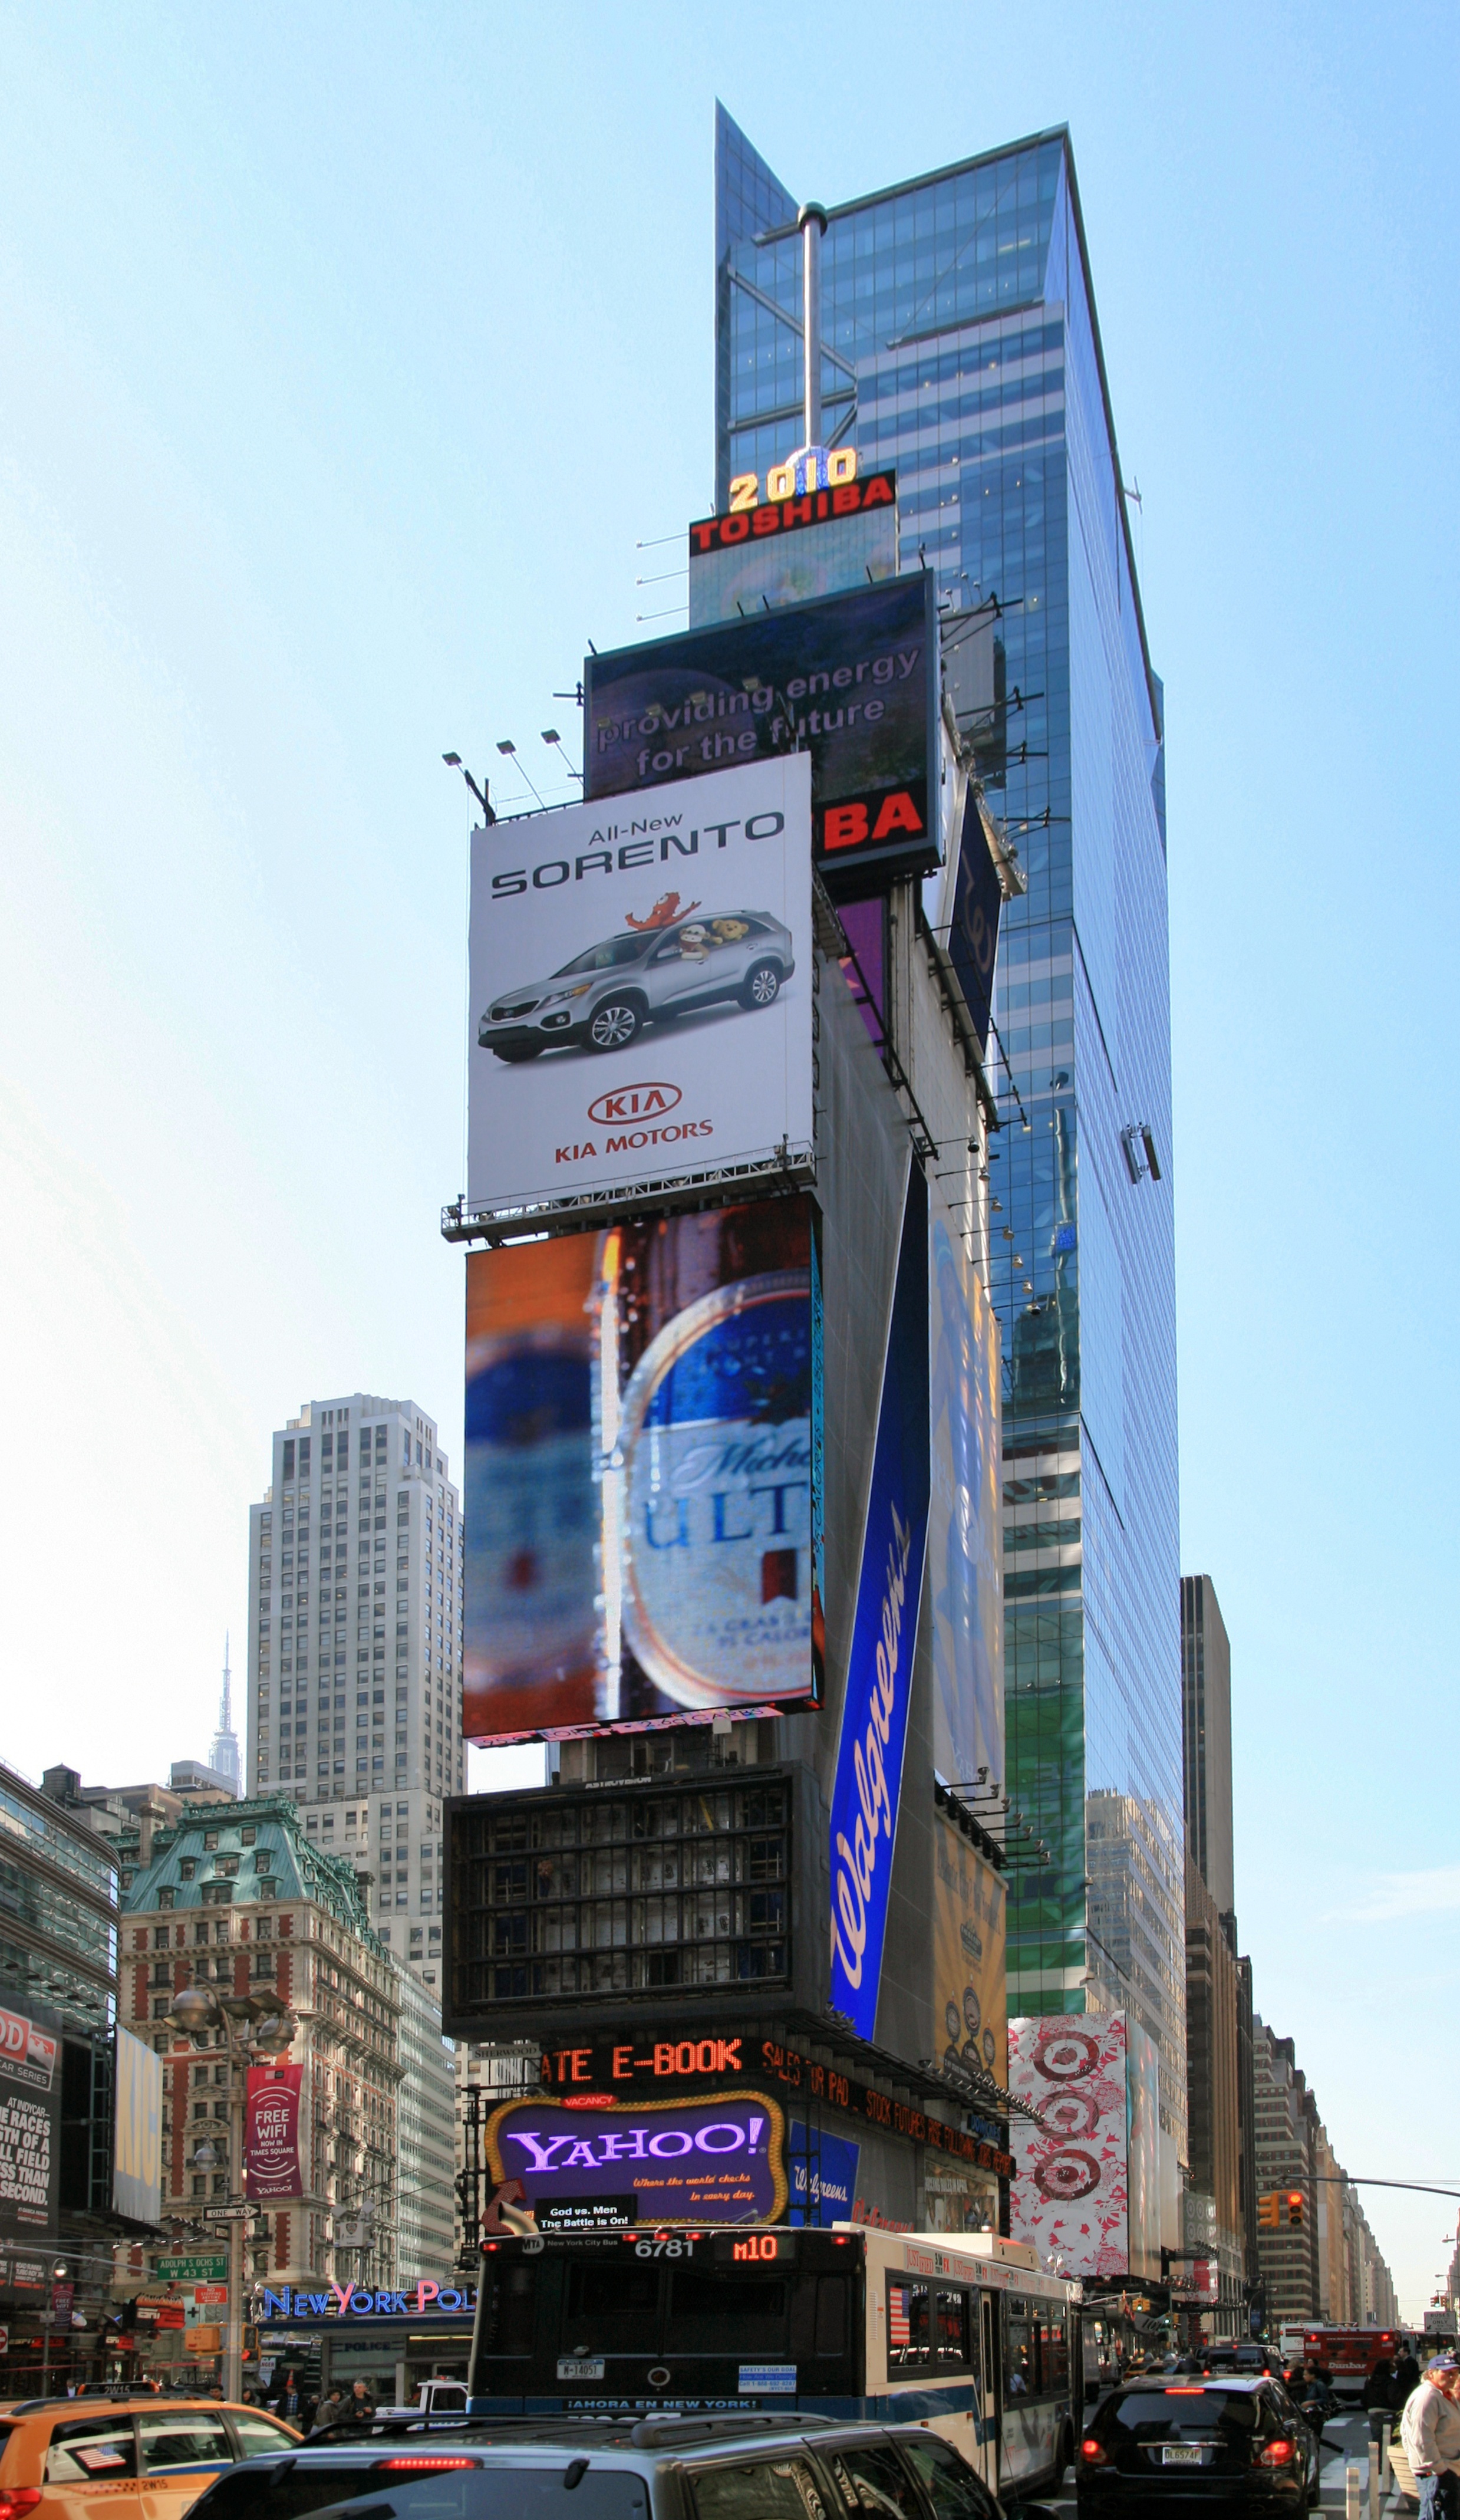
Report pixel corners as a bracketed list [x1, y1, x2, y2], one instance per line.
[249, 1391, 463, 1991]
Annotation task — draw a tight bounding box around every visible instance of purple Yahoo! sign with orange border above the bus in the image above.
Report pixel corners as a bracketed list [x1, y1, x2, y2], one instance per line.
[486, 2091, 785, 2223]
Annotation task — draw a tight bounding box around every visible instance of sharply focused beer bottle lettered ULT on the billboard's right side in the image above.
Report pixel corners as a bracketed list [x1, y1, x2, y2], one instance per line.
[604, 1199, 818, 1716]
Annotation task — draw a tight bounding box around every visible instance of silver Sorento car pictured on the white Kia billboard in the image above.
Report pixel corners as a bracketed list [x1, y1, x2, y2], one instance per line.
[476, 910, 796, 1066]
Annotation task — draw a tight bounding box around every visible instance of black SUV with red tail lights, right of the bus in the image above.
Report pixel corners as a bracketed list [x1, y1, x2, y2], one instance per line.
[1072, 2371, 1319, 2520]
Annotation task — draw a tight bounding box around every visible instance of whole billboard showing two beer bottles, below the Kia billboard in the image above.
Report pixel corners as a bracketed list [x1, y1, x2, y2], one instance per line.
[461, 1195, 820, 1744]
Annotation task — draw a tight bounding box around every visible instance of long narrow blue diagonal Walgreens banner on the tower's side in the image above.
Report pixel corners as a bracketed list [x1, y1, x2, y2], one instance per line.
[830, 1164, 929, 2039]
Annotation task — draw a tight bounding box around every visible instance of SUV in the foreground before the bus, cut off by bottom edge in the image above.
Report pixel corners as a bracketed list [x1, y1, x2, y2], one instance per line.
[192, 2414, 1054, 2520]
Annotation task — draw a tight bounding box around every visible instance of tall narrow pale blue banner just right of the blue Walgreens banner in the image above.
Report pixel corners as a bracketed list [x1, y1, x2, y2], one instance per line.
[929, 1197, 1004, 1784]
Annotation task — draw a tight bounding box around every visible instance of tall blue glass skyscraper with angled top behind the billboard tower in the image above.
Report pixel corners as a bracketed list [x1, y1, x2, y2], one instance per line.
[715, 108, 1185, 2157]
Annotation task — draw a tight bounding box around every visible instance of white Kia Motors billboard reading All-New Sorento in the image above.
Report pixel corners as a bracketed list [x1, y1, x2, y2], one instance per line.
[466, 754, 813, 1212]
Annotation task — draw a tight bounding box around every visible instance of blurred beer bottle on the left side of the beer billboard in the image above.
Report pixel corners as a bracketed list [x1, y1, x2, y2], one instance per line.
[463, 1235, 602, 1739]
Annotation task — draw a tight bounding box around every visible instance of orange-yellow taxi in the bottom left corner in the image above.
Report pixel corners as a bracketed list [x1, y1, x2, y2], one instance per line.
[0, 2397, 302, 2520]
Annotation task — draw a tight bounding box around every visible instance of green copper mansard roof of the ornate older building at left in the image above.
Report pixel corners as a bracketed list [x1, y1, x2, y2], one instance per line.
[121, 1794, 390, 1960]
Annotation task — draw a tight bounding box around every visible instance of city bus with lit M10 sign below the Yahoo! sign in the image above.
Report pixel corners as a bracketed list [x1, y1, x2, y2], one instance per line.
[468, 2223, 1082, 2498]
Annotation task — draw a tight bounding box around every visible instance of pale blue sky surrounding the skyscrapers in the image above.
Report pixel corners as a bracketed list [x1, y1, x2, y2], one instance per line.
[0, 0, 1460, 2308]
